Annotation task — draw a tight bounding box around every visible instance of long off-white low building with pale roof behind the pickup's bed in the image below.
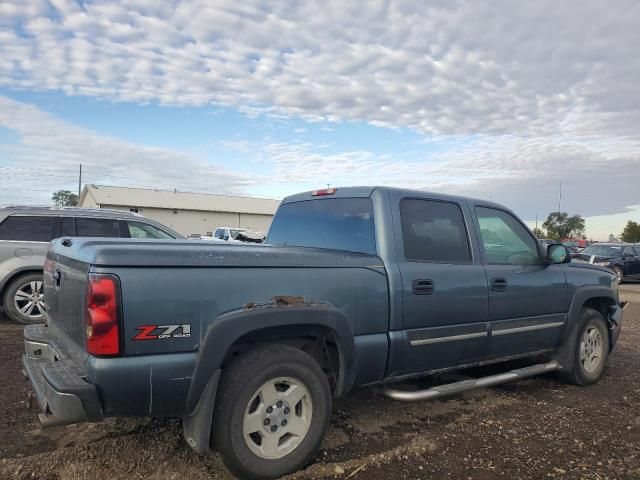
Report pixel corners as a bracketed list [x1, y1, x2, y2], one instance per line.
[78, 185, 280, 236]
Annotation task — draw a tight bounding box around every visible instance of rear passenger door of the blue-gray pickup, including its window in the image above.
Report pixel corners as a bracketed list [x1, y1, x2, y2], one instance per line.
[391, 192, 488, 374]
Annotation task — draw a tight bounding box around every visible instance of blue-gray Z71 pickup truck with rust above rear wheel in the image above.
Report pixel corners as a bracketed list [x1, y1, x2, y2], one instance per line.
[23, 187, 623, 478]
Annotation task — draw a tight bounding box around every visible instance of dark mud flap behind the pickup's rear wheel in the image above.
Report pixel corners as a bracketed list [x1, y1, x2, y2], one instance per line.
[182, 369, 220, 455]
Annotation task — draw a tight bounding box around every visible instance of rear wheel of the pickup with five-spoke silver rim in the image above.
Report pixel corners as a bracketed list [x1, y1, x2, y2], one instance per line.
[212, 345, 331, 479]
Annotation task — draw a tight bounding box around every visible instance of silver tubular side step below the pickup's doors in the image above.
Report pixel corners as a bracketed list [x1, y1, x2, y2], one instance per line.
[381, 361, 560, 402]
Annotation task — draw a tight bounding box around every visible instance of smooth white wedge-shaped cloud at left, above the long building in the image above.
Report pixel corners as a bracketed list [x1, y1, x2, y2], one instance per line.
[0, 96, 257, 203]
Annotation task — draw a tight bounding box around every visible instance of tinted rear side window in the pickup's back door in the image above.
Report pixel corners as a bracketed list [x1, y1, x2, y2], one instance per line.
[400, 199, 471, 263]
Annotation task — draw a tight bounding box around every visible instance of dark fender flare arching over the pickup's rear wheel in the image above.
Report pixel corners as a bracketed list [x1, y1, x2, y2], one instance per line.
[186, 304, 355, 413]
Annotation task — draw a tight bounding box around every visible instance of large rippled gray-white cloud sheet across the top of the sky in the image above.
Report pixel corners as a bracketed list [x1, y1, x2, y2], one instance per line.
[0, 0, 640, 135]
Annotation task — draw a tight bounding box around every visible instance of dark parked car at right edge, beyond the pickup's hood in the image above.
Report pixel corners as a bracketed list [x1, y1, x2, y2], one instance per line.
[571, 243, 640, 282]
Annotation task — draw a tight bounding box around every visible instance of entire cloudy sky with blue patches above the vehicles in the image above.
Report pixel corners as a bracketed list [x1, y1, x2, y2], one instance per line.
[0, 0, 640, 240]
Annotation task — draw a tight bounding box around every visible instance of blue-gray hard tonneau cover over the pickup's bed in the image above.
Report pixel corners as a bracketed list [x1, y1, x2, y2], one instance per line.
[47, 237, 382, 268]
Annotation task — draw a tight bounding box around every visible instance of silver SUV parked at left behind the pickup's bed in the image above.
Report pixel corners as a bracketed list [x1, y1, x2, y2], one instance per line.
[0, 207, 182, 323]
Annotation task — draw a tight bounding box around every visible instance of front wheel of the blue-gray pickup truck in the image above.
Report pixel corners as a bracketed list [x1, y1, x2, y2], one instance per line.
[560, 308, 609, 385]
